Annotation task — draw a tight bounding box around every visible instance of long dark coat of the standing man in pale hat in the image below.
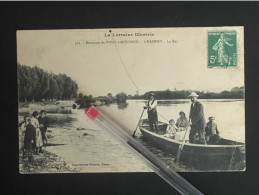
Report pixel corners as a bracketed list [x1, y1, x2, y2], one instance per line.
[190, 102, 206, 131]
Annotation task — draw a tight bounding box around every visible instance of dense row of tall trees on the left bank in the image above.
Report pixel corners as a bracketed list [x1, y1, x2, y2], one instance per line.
[17, 64, 78, 102]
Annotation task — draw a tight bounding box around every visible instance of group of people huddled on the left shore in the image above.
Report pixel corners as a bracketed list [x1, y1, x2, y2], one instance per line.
[20, 110, 48, 161]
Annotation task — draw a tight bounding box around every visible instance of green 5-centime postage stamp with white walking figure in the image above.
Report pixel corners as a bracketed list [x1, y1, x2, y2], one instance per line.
[208, 31, 237, 68]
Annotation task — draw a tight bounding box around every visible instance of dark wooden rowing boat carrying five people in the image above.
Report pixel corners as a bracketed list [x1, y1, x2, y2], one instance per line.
[139, 119, 245, 171]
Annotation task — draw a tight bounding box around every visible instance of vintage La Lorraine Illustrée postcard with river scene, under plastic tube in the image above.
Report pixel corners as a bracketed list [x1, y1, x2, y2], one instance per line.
[17, 27, 246, 174]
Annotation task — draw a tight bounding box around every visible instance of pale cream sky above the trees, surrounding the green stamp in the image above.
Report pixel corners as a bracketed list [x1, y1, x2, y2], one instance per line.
[17, 27, 244, 96]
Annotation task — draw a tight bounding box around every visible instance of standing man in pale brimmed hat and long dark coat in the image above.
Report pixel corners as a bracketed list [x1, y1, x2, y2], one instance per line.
[189, 92, 206, 144]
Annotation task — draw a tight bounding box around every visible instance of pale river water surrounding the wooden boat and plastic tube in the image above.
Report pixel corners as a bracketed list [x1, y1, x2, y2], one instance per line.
[46, 100, 245, 172]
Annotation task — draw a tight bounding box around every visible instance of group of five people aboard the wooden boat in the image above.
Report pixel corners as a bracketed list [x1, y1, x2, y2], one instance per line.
[144, 92, 220, 144]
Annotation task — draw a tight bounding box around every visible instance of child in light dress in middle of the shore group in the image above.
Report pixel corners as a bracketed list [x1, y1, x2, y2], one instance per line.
[31, 111, 43, 154]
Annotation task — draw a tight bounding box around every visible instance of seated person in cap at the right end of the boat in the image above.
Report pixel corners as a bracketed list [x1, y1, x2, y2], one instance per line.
[205, 116, 220, 144]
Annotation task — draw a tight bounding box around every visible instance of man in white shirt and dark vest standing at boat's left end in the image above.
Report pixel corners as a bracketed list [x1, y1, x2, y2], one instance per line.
[144, 93, 158, 133]
